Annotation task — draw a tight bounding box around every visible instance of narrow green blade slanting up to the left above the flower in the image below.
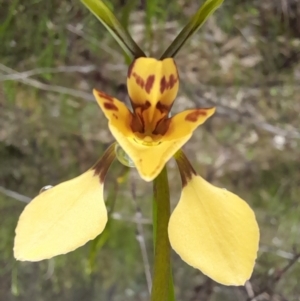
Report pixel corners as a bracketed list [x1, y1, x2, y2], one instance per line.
[81, 0, 146, 58]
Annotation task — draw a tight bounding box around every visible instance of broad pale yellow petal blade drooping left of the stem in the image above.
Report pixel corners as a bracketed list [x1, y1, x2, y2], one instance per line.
[14, 170, 107, 261]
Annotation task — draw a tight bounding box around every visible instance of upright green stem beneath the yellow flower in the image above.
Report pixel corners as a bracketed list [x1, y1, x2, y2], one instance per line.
[151, 167, 174, 301]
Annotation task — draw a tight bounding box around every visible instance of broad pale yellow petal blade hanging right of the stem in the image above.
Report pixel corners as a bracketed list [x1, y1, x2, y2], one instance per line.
[169, 174, 259, 285]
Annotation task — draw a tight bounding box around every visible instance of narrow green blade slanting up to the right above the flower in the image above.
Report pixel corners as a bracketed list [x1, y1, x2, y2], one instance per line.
[161, 0, 223, 59]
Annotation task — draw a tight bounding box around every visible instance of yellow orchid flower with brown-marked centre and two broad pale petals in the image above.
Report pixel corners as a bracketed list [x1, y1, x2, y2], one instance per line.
[14, 0, 259, 285]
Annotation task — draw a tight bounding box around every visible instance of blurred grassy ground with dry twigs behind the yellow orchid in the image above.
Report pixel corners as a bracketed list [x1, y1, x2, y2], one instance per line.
[0, 0, 300, 301]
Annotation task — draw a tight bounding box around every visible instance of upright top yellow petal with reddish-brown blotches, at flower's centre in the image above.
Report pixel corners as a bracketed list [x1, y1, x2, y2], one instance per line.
[127, 57, 179, 124]
